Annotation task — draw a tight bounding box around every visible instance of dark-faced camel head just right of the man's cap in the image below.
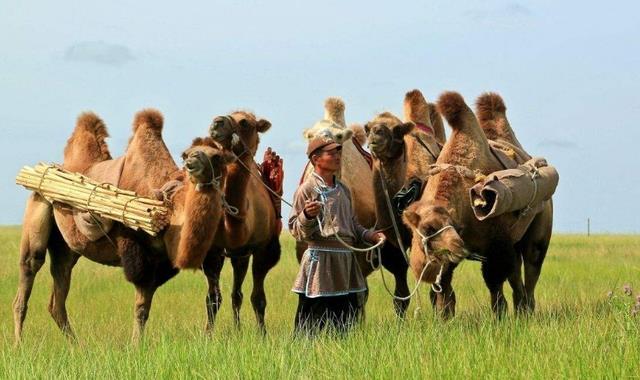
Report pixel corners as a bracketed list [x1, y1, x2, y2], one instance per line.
[364, 112, 414, 161]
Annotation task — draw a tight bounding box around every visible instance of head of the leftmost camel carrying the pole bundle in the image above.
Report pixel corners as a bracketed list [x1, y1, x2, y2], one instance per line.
[182, 137, 235, 190]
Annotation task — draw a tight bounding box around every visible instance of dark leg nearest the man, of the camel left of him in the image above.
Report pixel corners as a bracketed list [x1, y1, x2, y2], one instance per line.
[251, 236, 281, 334]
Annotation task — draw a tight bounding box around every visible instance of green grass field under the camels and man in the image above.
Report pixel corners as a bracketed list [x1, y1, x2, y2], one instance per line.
[0, 227, 640, 379]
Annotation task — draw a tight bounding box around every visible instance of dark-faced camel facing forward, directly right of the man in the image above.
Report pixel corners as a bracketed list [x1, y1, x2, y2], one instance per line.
[365, 90, 440, 311]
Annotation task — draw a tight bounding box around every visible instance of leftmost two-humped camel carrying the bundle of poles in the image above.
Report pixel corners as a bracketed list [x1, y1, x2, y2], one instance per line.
[13, 110, 232, 343]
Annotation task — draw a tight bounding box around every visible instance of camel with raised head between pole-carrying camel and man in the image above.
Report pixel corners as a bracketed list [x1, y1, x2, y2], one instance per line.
[208, 111, 282, 333]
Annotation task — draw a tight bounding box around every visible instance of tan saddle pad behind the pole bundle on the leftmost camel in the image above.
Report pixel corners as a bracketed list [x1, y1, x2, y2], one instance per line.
[72, 156, 124, 241]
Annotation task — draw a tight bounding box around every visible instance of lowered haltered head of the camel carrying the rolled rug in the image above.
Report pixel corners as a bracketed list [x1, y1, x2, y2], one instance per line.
[402, 201, 468, 263]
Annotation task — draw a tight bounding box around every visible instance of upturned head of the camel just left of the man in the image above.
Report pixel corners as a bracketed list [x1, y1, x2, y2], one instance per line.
[209, 111, 271, 157]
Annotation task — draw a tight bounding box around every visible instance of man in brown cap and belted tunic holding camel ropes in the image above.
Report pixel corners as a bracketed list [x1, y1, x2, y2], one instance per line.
[289, 137, 384, 334]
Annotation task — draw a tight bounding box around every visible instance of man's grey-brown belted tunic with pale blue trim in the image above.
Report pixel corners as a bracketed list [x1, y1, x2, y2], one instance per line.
[289, 173, 367, 298]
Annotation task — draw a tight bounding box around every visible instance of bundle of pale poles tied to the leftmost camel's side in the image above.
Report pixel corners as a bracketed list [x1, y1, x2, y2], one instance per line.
[16, 163, 170, 236]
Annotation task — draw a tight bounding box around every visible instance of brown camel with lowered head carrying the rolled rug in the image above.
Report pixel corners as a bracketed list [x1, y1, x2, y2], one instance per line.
[403, 92, 551, 318]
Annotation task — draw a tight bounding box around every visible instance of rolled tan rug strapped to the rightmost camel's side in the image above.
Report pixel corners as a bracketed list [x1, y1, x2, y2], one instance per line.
[469, 157, 559, 220]
